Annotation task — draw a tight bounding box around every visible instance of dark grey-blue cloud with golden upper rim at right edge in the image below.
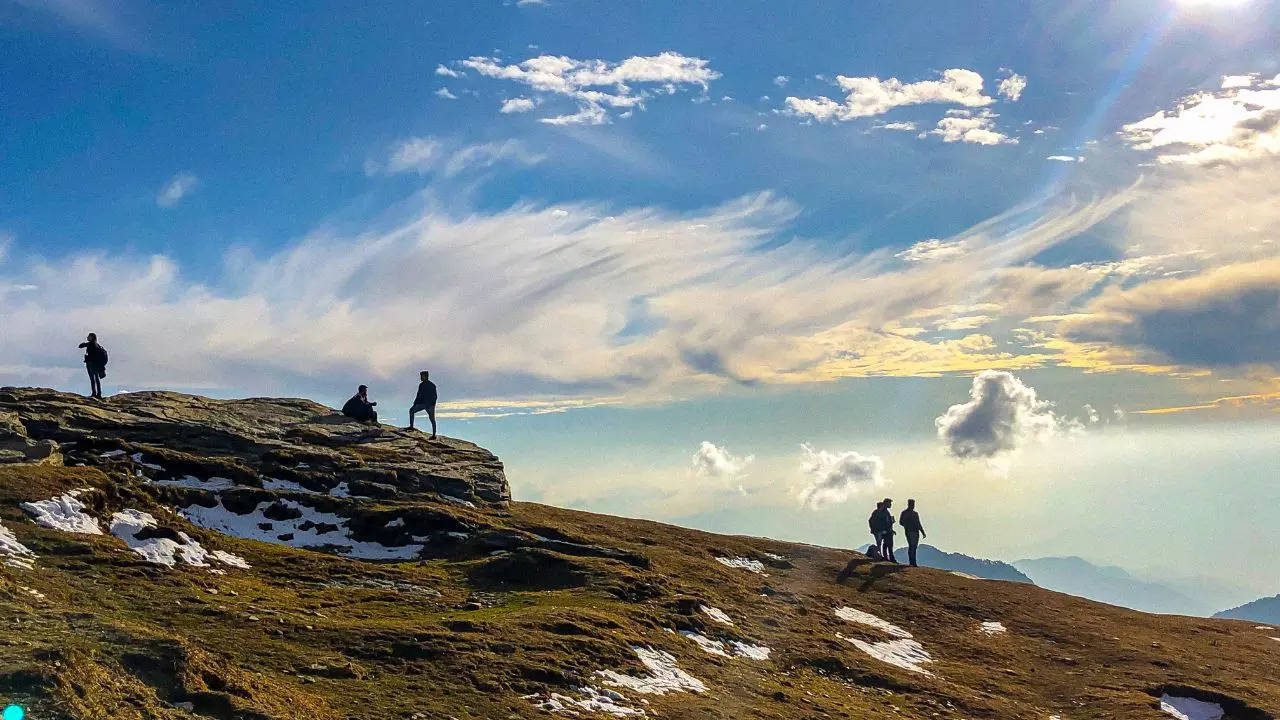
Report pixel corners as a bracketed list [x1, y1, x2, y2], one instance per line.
[1059, 259, 1280, 368]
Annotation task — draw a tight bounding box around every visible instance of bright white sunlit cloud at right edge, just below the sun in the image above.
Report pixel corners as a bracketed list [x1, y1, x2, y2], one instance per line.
[1120, 76, 1280, 165]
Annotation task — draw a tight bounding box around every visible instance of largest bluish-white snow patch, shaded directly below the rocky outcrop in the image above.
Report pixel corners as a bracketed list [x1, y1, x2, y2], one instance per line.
[179, 498, 422, 560]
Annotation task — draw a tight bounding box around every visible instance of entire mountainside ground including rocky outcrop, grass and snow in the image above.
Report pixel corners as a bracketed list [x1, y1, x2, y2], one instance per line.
[0, 388, 1280, 720]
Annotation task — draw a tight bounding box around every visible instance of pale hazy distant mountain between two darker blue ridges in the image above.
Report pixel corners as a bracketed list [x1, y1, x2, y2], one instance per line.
[1014, 556, 1213, 616]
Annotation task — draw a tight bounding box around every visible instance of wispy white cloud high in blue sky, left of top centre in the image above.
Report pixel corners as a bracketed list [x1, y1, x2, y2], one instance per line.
[456, 51, 721, 124]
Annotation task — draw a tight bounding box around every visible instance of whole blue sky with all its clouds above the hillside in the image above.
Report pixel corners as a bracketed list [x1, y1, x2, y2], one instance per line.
[0, 0, 1280, 594]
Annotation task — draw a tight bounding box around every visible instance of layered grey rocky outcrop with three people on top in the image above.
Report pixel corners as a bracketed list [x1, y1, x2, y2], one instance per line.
[0, 387, 511, 506]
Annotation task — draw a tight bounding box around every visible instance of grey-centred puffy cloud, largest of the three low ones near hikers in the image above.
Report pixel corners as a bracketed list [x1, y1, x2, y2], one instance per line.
[934, 370, 1061, 460]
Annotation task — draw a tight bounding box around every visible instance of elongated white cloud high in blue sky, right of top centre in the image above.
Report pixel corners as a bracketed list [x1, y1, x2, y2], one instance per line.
[786, 68, 996, 122]
